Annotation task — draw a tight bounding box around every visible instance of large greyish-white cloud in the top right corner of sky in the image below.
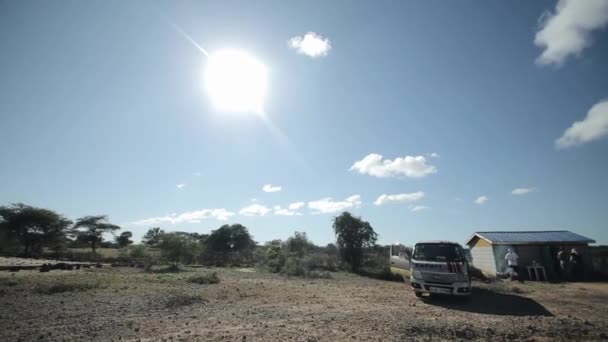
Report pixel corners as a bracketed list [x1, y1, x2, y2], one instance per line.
[534, 0, 608, 65]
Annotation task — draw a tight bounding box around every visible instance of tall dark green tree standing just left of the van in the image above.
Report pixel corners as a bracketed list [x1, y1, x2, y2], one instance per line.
[333, 211, 378, 272]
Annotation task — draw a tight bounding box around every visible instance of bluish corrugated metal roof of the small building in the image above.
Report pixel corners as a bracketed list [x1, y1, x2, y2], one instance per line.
[467, 230, 595, 244]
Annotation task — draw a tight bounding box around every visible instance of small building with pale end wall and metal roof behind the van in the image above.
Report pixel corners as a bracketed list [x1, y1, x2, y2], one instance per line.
[467, 230, 595, 280]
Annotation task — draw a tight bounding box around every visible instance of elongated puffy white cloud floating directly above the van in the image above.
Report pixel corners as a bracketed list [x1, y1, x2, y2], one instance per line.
[350, 153, 437, 178]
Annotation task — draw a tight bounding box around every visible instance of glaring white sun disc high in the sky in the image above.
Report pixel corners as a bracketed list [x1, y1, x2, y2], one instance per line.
[204, 49, 267, 114]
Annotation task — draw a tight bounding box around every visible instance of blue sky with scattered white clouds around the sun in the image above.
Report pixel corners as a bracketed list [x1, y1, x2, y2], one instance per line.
[0, 0, 608, 245]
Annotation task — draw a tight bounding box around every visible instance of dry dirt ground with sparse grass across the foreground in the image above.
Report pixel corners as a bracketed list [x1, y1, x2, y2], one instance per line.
[0, 268, 608, 341]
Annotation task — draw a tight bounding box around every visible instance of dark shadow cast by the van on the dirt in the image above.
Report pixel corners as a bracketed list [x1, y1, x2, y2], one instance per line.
[424, 288, 553, 316]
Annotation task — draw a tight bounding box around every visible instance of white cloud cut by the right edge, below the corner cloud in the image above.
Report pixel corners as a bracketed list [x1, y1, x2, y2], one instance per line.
[555, 100, 608, 149]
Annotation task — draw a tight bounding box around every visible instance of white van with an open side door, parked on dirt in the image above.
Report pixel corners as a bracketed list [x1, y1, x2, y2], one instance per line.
[390, 241, 471, 297]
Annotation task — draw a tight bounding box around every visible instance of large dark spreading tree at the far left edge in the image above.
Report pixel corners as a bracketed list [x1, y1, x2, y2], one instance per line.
[0, 203, 72, 256]
